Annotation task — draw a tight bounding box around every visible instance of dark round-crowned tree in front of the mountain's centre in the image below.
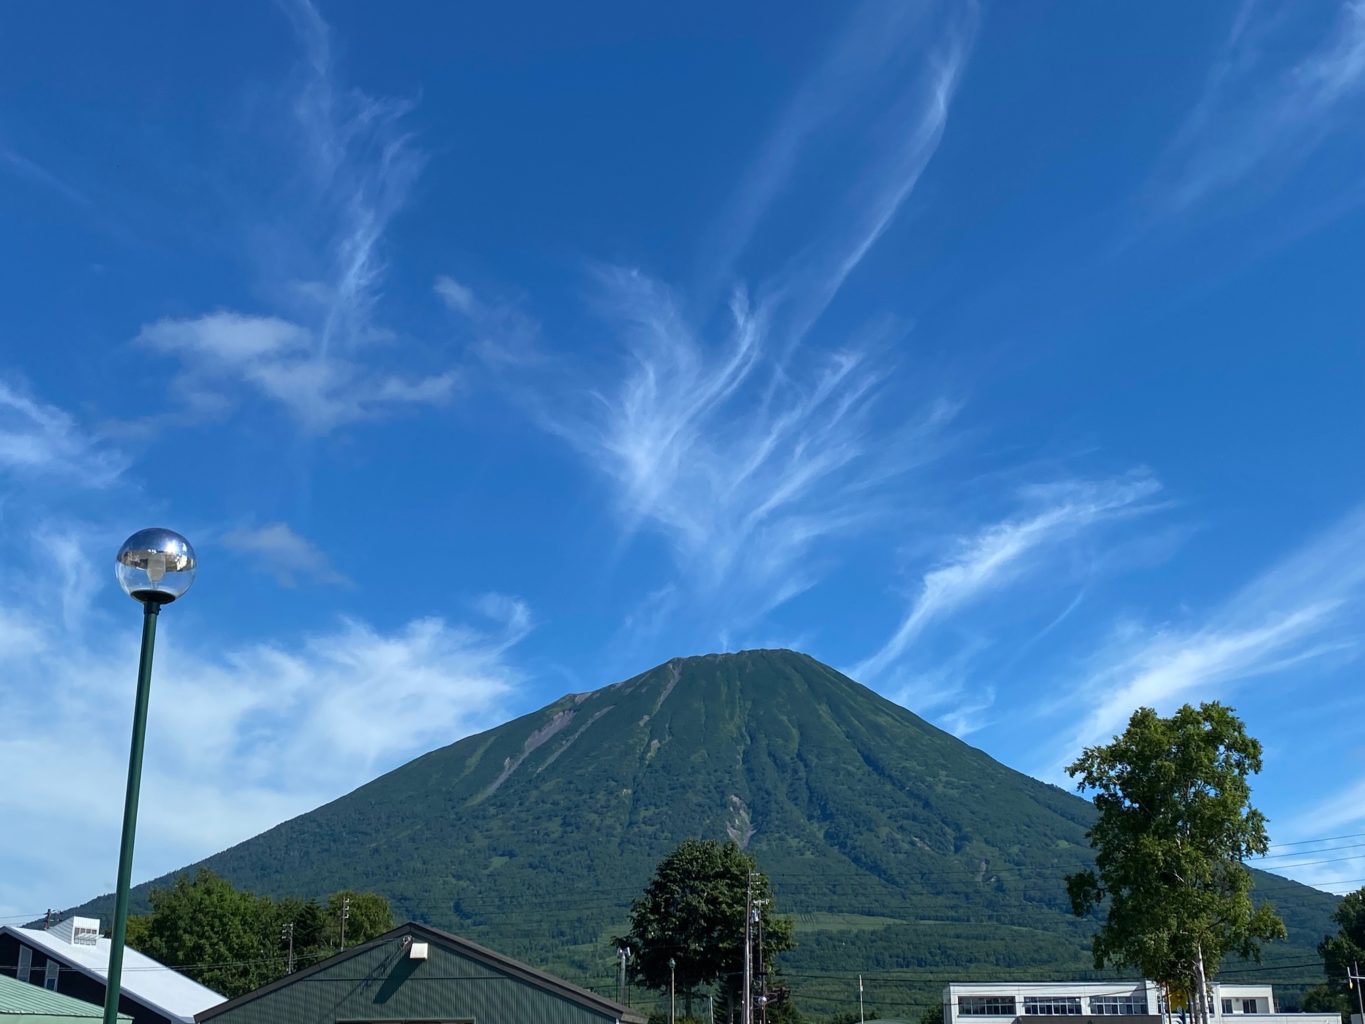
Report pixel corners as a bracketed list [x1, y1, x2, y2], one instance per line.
[616, 840, 792, 1014]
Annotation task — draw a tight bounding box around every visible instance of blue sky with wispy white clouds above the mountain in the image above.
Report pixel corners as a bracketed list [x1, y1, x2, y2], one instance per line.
[0, 0, 1365, 918]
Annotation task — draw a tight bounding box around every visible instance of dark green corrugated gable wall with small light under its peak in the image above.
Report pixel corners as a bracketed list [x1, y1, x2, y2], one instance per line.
[203, 938, 625, 1024]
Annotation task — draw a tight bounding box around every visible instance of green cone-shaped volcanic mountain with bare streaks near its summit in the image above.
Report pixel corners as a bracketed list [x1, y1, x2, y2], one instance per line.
[72, 651, 1335, 1016]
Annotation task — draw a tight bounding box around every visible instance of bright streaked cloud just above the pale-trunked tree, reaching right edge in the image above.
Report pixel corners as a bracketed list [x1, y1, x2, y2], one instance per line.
[1046, 508, 1365, 775]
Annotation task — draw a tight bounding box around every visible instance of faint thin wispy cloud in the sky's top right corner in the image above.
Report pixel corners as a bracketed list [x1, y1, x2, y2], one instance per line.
[1153, 0, 1365, 210]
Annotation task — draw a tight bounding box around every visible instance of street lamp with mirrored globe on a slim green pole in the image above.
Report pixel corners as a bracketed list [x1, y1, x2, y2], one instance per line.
[104, 528, 199, 1024]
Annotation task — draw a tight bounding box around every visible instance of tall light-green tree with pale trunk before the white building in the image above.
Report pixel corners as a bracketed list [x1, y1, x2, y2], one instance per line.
[1066, 703, 1286, 1023]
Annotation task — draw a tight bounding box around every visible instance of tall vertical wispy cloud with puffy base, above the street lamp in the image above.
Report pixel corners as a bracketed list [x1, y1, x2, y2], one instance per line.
[137, 0, 456, 433]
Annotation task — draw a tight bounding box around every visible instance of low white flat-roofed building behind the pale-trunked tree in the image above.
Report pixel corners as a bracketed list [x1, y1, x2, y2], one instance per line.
[943, 982, 1340, 1024]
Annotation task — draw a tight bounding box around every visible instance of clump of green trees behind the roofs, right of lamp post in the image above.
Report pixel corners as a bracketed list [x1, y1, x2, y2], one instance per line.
[127, 868, 393, 998]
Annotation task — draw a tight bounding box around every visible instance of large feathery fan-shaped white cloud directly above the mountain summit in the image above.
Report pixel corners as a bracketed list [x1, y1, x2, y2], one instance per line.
[541, 270, 954, 614]
